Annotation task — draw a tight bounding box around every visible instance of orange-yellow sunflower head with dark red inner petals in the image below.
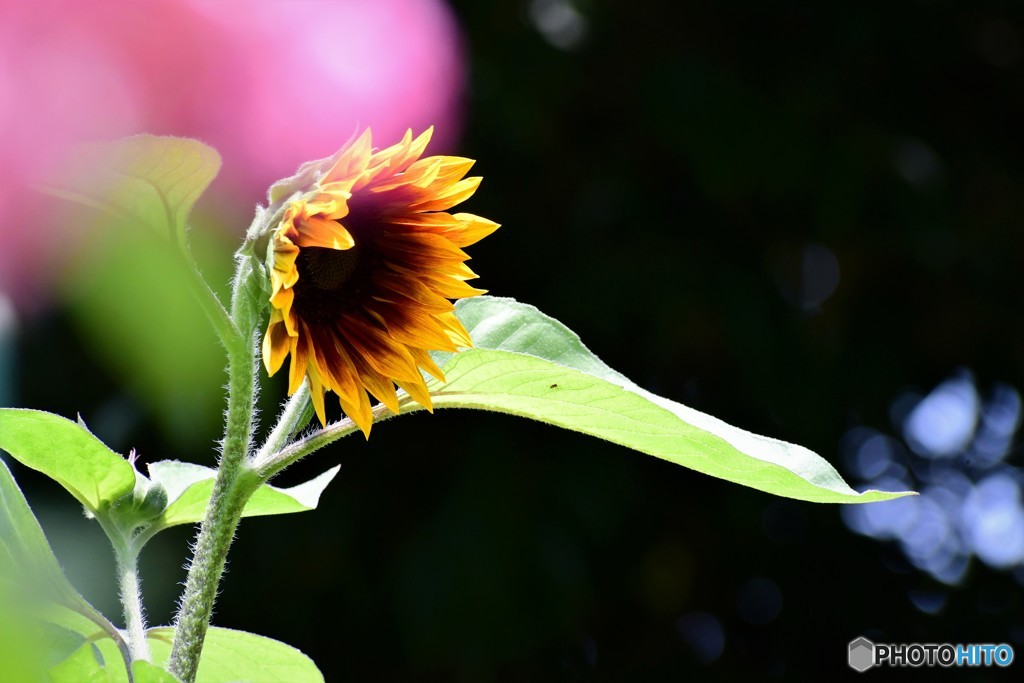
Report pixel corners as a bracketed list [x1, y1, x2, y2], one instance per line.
[263, 129, 498, 436]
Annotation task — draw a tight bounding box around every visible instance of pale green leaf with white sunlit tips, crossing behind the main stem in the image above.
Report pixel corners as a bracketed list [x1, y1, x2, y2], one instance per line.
[150, 460, 341, 528]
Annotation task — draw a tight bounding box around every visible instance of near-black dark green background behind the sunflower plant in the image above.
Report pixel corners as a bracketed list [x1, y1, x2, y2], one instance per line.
[8, 0, 1024, 682]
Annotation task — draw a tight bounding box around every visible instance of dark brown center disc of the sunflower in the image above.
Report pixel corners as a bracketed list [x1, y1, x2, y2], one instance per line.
[293, 244, 374, 325]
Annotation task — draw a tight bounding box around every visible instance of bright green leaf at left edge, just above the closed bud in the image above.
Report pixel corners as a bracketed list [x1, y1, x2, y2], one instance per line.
[0, 408, 135, 512]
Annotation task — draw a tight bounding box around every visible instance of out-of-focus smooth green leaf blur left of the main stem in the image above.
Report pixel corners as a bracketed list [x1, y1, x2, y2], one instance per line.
[61, 232, 229, 452]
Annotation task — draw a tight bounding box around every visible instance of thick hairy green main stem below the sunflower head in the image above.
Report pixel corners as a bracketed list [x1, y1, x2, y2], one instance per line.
[168, 253, 259, 683]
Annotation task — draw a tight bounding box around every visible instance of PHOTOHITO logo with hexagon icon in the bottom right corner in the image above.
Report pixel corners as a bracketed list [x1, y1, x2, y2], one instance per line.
[847, 636, 1014, 672]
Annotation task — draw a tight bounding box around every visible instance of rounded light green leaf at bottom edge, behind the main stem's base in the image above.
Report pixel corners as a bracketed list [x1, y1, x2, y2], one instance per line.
[146, 627, 324, 683]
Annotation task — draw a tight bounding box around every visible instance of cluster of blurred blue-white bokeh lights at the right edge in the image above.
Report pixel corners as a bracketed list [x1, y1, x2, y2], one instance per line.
[842, 371, 1024, 589]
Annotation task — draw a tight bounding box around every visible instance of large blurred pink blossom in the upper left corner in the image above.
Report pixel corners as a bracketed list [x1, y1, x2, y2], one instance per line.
[0, 0, 464, 305]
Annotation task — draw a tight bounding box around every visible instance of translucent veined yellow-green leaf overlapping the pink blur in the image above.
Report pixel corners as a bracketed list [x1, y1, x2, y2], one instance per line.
[43, 135, 220, 242]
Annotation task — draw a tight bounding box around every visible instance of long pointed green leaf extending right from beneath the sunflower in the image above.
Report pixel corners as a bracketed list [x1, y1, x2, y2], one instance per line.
[429, 297, 908, 503]
